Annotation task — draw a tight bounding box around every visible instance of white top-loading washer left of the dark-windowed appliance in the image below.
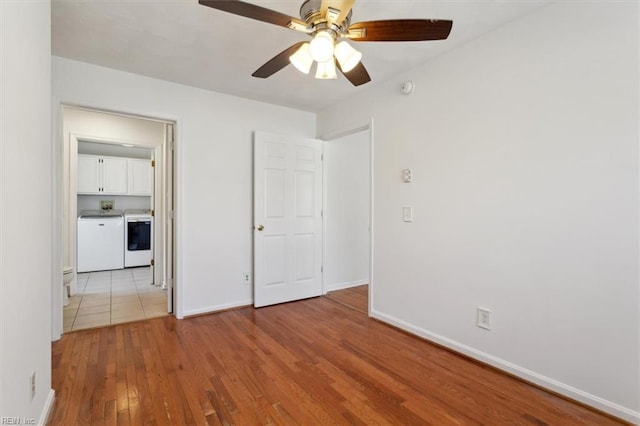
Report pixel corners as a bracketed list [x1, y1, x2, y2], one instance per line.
[78, 210, 124, 272]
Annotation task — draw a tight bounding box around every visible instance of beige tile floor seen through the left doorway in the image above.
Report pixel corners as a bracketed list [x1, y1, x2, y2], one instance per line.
[63, 266, 167, 332]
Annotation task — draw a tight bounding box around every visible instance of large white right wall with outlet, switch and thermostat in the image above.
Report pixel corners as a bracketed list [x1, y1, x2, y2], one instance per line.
[318, 2, 640, 422]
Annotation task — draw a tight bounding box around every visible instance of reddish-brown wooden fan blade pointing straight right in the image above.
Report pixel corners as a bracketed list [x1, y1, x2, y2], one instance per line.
[347, 19, 453, 41]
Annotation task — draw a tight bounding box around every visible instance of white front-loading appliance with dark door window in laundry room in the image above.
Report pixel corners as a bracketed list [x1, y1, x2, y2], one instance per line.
[124, 210, 153, 268]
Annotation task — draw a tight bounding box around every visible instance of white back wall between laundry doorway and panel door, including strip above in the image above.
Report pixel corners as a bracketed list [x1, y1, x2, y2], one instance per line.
[52, 57, 316, 316]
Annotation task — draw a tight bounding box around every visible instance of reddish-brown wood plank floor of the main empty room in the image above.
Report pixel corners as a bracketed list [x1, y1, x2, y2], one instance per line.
[49, 297, 621, 425]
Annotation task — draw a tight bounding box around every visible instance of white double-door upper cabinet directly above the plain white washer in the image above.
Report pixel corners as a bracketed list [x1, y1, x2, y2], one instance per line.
[78, 154, 129, 195]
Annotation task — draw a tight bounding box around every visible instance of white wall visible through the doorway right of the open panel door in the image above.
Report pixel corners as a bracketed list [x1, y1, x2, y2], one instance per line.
[323, 129, 371, 292]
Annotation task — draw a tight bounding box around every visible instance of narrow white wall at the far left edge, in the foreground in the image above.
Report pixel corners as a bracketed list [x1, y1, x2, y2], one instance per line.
[0, 1, 53, 424]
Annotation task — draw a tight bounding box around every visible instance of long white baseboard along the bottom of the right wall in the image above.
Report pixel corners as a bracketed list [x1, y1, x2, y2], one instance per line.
[370, 309, 640, 424]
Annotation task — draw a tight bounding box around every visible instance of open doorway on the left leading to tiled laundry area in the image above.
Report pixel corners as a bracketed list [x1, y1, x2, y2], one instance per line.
[54, 106, 175, 332]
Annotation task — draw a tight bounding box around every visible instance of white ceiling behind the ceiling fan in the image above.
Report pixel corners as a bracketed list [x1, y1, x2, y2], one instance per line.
[51, 0, 550, 111]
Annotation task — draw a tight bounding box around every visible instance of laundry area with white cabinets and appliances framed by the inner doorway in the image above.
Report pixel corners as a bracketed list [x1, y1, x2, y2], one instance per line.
[77, 140, 154, 273]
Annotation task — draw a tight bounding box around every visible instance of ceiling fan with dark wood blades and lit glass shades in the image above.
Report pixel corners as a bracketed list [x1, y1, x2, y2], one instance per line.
[199, 0, 453, 86]
